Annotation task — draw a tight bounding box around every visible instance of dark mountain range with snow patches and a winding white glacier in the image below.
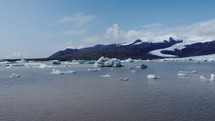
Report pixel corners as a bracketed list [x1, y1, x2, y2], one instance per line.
[49, 37, 215, 60]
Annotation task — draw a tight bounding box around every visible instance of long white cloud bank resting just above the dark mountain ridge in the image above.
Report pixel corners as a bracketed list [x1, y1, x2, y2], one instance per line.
[82, 19, 215, 44]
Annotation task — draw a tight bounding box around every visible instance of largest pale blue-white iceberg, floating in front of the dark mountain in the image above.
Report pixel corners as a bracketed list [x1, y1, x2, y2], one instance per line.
[95, 56, 122, 67]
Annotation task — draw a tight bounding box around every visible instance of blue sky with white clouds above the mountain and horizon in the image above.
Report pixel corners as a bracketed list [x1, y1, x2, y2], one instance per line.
[0, 0, 215, 58]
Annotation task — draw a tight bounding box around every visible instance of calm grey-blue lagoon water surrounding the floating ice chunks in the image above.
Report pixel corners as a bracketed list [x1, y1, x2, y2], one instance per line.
[0, 62, 215, 121]
